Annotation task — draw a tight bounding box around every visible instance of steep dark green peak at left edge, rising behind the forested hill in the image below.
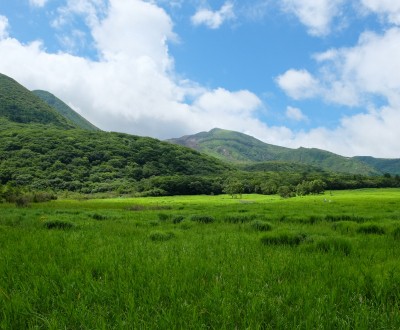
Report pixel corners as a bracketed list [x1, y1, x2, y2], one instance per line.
[0, 74, 76, 129]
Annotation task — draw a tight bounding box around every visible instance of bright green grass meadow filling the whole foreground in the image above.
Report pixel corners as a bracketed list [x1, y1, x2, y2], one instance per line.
[0, 189, 400, 329]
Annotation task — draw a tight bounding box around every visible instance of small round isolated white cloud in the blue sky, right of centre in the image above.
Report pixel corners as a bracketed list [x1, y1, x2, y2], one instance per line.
[276, 69, 318, 100]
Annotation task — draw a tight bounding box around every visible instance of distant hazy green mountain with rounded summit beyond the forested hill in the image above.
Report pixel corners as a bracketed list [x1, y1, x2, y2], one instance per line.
[168, 128, 381, 175]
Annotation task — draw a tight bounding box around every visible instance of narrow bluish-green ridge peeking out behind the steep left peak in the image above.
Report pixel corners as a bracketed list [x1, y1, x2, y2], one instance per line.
[32, 90, 99, 131]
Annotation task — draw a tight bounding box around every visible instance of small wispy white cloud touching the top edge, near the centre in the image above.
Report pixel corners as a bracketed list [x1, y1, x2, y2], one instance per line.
[191, 1, 235, 29]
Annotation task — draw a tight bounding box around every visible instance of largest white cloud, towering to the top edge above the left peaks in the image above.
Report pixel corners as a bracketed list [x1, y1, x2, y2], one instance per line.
[0, 0, 269, 138]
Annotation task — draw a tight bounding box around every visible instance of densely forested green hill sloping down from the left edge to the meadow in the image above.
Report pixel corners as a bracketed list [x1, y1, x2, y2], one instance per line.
[0, 118, 229, 193]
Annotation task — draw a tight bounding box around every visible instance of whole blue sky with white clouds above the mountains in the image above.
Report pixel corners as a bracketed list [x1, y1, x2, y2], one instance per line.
[0, 0, 400, 158]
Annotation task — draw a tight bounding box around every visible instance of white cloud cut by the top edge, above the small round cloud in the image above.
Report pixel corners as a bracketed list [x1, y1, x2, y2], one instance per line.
[282, 0, 344, 36]
